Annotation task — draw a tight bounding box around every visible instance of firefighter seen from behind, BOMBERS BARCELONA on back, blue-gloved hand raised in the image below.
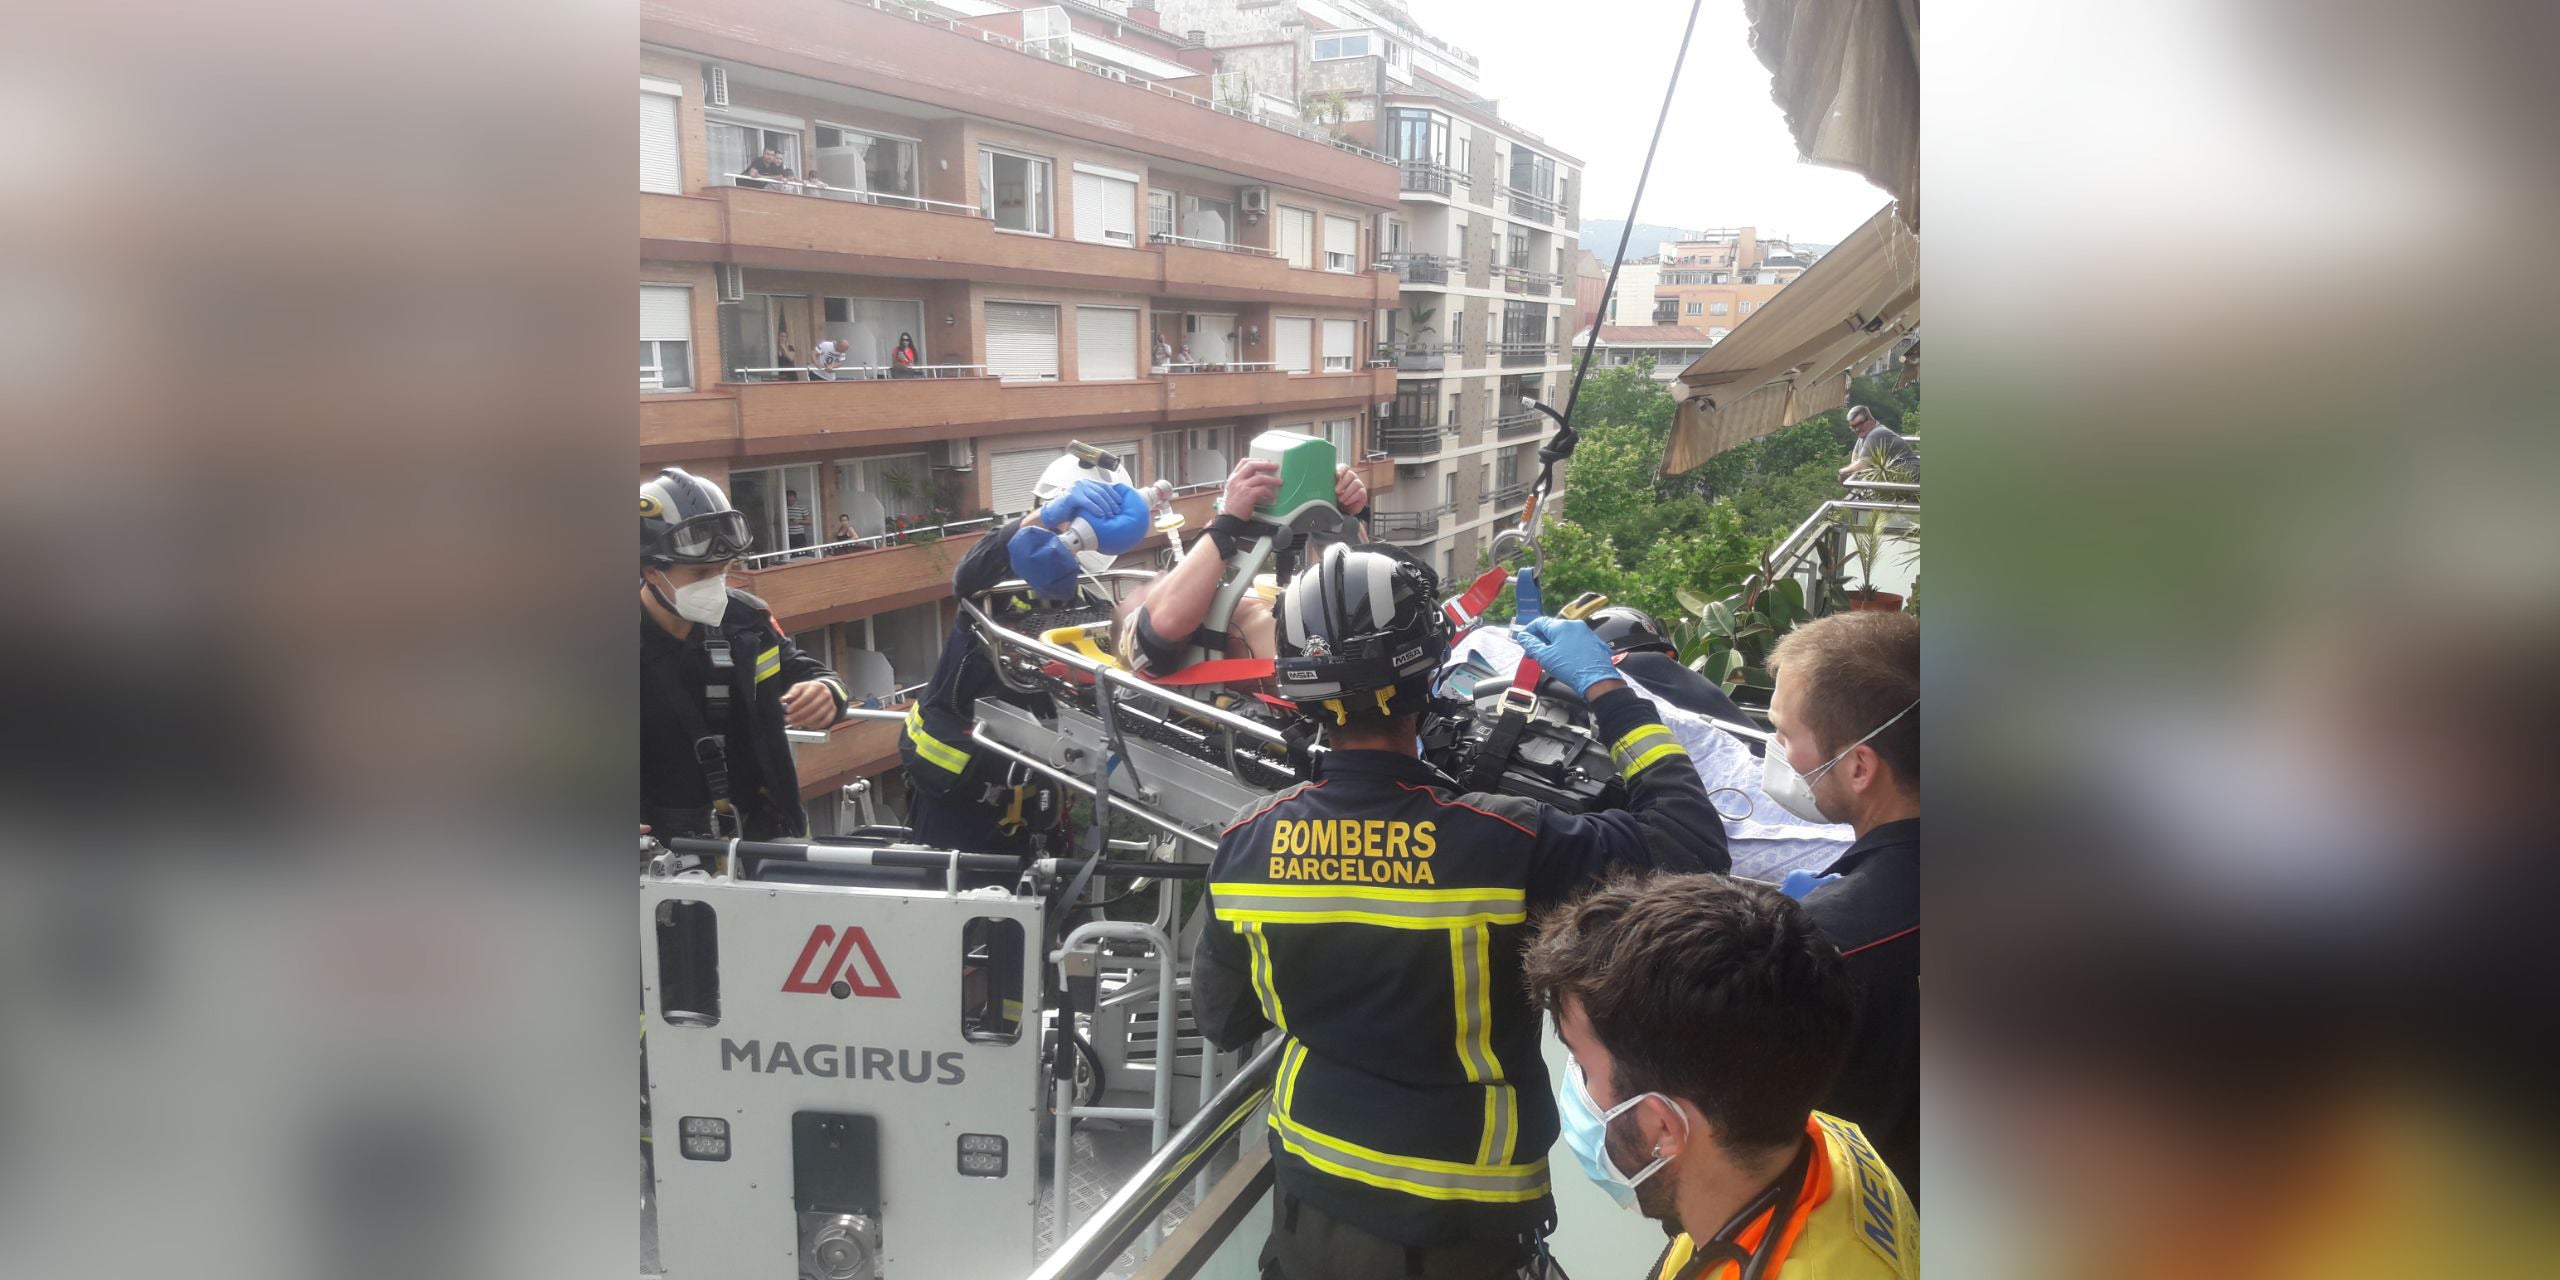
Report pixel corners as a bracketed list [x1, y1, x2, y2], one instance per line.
[1193, 545, 1731, 1280]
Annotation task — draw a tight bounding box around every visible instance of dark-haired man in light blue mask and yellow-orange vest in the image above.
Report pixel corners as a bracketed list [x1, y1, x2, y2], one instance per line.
[1526, 876, 1920, 1280]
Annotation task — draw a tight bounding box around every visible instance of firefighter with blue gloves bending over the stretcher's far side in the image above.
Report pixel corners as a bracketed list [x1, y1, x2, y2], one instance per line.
[899, 451, 1152, 858]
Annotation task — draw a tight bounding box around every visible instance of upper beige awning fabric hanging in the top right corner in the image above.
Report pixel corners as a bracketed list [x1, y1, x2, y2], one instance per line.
[1743, 0, 1920, 230]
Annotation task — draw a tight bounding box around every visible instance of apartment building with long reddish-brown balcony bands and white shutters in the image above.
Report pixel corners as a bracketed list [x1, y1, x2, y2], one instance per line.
[640, 0, 1403, 829]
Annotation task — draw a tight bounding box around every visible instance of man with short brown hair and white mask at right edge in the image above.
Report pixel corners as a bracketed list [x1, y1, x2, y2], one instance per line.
[1761, 612, 1920, 1203]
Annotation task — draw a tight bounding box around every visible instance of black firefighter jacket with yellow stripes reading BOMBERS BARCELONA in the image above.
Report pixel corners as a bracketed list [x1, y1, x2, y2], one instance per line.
[1193, 689, 1731, 1247]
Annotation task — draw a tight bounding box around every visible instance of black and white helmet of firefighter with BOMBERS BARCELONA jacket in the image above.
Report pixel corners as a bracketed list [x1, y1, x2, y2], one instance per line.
[1272, 543, 1449, 724]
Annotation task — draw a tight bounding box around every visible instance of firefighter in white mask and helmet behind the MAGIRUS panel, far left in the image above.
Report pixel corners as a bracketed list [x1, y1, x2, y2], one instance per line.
[640, 466, 850, 840]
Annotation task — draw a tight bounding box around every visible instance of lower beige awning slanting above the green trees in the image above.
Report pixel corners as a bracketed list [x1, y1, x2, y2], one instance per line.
[1661, 205, 1920, 476]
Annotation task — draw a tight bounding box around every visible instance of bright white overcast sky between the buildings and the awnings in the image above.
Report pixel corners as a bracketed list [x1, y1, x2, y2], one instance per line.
[1405, 0, 1887, 261]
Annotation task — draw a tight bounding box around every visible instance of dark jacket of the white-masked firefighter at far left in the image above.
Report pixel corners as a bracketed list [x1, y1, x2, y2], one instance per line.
[640, 591, 852, 840]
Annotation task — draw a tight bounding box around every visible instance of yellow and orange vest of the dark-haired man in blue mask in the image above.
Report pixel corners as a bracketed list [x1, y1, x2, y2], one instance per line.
[1651, 1111, 1920, 1280]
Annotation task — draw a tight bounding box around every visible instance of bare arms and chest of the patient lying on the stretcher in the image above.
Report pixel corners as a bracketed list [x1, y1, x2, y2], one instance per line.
[1111, 458, 1370, 684]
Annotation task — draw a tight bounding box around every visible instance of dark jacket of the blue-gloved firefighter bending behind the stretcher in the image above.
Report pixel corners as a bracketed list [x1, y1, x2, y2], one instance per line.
[899, 520, 1065, 852]
